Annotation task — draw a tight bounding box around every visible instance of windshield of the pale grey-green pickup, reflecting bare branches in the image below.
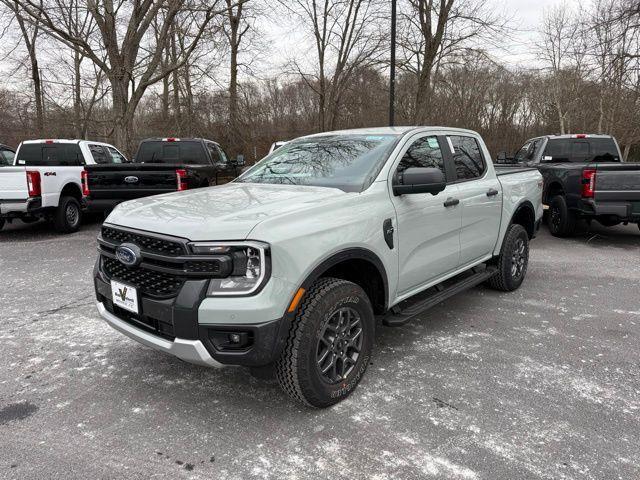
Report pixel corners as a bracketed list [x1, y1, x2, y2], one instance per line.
[236, 134, 398, 192]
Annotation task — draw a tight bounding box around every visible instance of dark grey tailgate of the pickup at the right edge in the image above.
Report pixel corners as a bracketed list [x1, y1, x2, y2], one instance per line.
[589, 163, 640, 202]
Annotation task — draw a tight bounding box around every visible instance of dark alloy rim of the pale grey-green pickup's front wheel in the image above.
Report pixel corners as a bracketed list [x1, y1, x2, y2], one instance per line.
[316, 307, 362, 384]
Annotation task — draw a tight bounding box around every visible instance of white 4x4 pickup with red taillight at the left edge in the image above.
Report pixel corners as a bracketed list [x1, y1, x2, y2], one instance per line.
[0, 140, 127, 233]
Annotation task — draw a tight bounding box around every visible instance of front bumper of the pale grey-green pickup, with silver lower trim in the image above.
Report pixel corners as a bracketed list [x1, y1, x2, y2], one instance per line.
[94, 260, 291, 367]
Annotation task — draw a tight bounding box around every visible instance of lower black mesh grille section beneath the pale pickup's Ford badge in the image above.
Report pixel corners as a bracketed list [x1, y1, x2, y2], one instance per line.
[102, 256, 184, 297]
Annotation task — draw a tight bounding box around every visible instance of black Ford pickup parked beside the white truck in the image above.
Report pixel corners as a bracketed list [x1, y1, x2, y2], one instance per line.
[82, 138, 242, 212]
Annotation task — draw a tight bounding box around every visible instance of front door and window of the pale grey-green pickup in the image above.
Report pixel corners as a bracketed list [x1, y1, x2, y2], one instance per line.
[392, 135, 461, 296]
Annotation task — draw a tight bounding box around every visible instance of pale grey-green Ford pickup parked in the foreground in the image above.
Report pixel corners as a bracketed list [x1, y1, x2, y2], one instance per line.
[94, 127, 542, 407]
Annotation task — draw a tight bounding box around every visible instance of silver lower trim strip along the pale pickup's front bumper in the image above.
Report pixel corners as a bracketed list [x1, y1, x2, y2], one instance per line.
[97, 302, 223, 368]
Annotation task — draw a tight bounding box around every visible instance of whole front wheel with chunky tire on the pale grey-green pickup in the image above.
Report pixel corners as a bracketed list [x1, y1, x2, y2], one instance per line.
[276, 278, 375, 408]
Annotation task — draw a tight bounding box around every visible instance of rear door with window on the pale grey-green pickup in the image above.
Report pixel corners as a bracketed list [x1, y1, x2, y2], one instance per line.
[447, 134, 502, 267]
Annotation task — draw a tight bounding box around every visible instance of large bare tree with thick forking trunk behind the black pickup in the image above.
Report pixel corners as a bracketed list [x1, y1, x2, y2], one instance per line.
[1, 0, 220, 150]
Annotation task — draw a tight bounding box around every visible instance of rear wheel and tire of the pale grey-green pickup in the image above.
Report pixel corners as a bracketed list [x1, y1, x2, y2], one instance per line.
[488, 224, 529, 292]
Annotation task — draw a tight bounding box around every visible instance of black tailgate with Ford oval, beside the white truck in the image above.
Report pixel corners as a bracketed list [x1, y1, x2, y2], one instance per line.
[86, 164, 181, 200]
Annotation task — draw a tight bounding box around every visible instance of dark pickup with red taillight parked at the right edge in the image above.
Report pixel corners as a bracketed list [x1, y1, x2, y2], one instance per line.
[498, 134, 640, 237]
